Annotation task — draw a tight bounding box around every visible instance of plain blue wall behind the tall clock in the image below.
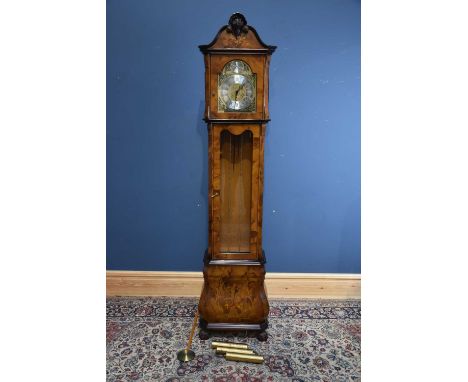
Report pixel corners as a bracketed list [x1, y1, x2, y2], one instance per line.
[107, 0, 361, 273]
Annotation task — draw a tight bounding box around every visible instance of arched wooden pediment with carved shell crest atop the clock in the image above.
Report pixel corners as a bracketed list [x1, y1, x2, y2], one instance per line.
[199, 13, 276, 54]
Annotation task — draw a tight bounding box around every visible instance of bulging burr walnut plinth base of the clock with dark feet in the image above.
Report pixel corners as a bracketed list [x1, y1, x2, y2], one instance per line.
[198, 251, 270, 340]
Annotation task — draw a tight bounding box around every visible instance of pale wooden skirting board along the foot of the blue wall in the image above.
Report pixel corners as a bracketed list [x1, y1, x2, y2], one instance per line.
[106, 271, 361, 299]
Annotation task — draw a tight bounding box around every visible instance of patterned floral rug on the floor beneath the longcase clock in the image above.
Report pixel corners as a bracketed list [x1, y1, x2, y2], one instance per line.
[107, 297, 361, 382]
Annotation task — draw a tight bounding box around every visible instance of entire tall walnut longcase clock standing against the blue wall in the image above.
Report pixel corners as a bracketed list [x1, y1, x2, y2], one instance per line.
[199, 13, 276, 341]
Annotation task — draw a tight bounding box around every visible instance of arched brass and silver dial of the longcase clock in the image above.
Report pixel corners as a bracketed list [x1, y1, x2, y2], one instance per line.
[218, 60, 256, 112]
